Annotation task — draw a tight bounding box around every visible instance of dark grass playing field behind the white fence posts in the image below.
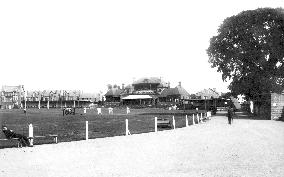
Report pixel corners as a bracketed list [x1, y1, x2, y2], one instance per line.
[0, 108, 205, 148]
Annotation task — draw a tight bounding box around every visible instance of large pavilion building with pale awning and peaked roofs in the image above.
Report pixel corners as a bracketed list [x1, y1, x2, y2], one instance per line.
[105, 77, 189, 107]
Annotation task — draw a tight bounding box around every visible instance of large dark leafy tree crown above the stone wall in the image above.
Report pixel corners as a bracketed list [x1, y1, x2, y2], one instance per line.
[207, 8, 284, 100]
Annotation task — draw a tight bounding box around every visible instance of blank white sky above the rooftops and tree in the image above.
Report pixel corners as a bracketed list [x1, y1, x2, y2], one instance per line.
[0, 0, 284, 94]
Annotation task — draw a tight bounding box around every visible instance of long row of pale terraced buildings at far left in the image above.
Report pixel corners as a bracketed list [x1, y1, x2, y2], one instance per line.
[0, 85, 101, 109]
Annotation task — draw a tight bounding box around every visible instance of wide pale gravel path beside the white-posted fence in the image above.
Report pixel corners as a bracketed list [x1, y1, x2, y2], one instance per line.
[0, 111, 284, 177]
